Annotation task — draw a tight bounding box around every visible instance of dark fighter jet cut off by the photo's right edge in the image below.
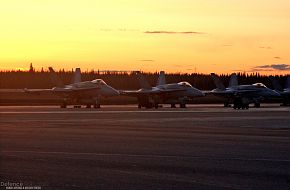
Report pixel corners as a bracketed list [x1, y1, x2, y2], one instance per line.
[270, 76, 290, 106]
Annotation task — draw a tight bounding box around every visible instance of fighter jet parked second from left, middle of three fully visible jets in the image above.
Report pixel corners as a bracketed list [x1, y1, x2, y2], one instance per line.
[121, 71, 204, 109]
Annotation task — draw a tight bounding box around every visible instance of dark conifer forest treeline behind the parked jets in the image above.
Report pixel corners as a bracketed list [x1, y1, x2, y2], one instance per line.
[0, 69, 287, 90]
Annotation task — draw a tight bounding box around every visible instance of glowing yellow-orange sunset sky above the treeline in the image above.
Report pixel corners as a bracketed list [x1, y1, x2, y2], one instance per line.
[0, 0, 290, 74]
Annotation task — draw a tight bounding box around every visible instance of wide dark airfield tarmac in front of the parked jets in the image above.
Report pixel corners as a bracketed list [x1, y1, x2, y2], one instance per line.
[0, 104, 290, 190]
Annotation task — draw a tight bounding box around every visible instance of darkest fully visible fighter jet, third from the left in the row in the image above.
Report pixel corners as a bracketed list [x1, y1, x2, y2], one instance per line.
[210, 73, 280, 109]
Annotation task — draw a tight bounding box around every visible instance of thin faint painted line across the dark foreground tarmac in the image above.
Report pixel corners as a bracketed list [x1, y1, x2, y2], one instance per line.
[1, 150, 290, 163]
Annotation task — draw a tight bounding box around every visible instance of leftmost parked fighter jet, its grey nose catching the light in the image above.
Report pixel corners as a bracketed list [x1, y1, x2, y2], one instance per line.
[25, 67, 119, 108]
